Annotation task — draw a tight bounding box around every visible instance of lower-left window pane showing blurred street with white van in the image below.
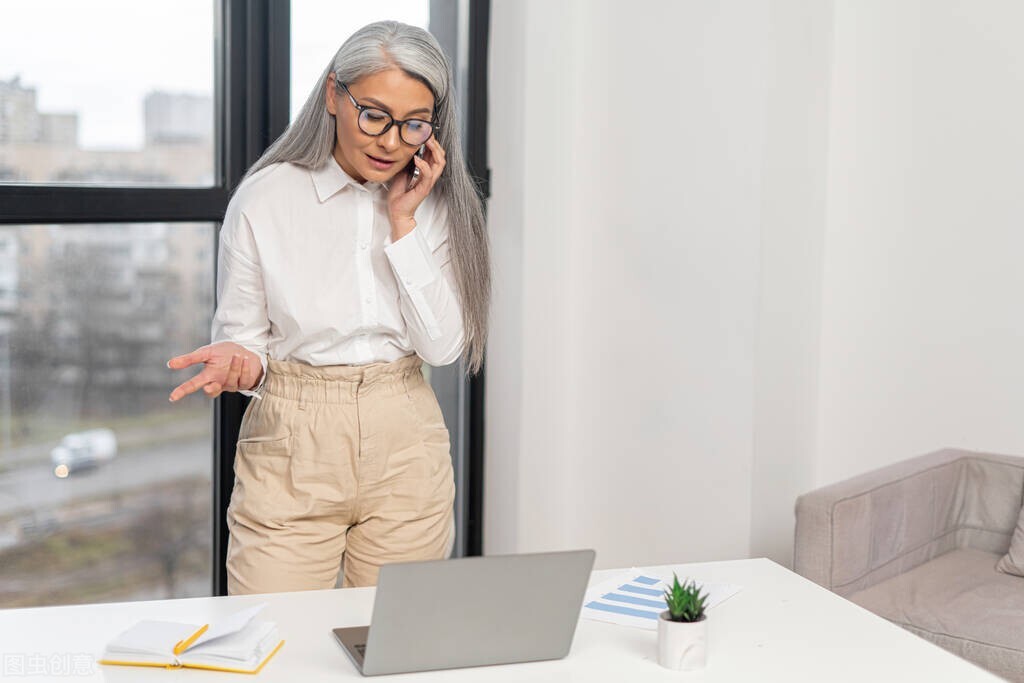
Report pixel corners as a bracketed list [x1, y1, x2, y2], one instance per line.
[0, 223, 214, 607]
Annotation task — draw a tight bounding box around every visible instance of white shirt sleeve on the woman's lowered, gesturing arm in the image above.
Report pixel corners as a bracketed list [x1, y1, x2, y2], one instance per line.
[210, 205, 270, 398]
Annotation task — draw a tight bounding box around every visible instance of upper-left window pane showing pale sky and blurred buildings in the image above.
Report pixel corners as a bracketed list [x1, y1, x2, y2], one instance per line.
[0, 0, 215, 186]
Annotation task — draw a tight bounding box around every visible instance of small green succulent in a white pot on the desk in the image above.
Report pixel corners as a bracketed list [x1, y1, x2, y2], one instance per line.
[657, 573, 708, 671]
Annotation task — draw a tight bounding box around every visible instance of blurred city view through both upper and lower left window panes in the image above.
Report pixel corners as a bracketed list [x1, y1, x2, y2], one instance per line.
[0, 0, 216, 607]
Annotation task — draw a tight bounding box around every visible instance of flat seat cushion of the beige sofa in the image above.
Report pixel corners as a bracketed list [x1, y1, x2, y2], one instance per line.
[849, 548, 1024, 681]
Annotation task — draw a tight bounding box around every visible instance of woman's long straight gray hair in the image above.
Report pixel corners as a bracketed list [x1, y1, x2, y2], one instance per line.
[237, 22, 490, 374]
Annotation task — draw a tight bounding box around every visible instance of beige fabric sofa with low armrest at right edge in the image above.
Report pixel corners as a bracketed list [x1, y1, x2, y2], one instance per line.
[794, 450, 1024, 682]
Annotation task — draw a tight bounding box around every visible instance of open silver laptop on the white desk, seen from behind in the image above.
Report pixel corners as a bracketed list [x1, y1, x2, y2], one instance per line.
[333, 550, 594, 676]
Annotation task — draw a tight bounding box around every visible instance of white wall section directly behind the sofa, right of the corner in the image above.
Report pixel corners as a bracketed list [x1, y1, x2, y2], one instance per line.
[815, 0, 1024, 483]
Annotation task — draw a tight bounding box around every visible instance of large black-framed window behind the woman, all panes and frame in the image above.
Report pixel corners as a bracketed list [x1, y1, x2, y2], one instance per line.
[0, 0, 486, 607]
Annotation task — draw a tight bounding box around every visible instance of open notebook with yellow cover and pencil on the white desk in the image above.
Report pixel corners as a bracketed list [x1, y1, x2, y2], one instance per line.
[99, 602, 285, 674]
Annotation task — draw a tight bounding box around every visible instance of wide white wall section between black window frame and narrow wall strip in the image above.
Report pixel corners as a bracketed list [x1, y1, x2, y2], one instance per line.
[484, 1, 768, 566]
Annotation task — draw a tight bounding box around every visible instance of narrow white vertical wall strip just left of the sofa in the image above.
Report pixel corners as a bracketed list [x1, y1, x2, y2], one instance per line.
[750, 0, 833, 566]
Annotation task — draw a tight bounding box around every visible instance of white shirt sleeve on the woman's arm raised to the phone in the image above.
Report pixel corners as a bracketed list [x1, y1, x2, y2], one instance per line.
[384, 199, 465, 366]
